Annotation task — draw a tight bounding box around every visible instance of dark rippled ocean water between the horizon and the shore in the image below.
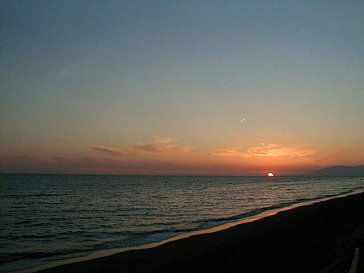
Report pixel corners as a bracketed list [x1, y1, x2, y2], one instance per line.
[0, 174, 364, 273]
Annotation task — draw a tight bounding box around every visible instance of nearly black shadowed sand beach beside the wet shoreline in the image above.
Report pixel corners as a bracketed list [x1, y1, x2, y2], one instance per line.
[42, 193, 364, 273]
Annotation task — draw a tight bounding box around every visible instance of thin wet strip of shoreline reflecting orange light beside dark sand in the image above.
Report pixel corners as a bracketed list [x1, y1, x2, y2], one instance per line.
[26, 190, 364, 273]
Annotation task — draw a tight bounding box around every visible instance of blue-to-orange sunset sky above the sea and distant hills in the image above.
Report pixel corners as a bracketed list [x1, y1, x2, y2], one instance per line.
[0, 0, 364, 175]
